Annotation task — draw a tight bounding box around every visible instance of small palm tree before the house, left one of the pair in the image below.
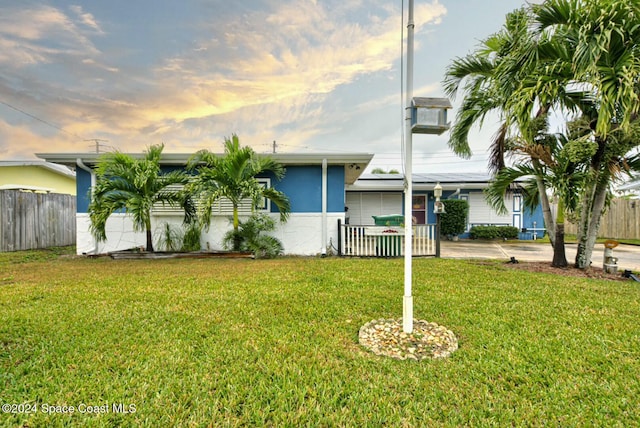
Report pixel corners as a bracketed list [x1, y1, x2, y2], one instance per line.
[89, 144, 195, 251]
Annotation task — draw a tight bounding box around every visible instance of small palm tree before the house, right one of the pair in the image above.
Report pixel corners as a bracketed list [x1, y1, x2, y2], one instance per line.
[188, 134, 290, 250]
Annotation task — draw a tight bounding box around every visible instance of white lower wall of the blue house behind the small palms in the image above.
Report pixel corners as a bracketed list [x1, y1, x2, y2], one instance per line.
[76, 213, 344, 256]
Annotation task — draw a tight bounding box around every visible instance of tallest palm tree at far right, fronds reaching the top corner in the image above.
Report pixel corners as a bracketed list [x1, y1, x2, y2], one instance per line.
[531, 0, 640, 268]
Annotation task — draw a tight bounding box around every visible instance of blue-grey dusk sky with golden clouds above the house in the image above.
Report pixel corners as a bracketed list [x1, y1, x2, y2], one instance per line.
[0, 0, 524, 172]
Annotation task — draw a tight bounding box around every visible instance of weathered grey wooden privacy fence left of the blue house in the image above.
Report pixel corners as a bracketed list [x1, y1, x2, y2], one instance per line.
[0, 190, 76, 252]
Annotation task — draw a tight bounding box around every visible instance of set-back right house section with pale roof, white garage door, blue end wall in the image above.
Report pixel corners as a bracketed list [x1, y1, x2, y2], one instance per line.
[346, 173, 544, 239]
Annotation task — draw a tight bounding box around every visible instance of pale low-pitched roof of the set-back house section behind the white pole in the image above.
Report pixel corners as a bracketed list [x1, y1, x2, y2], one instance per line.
[346, 172, 524, 192]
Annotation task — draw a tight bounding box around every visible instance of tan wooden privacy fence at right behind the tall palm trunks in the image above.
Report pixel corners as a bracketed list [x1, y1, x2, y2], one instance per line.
[565, 199, 640, 239]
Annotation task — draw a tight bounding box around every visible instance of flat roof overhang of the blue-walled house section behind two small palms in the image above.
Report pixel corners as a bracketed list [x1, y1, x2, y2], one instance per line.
[36, 153, 373, 184]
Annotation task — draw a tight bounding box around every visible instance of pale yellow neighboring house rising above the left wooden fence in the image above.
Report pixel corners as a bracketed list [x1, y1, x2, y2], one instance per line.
[0, 160, 76, 195]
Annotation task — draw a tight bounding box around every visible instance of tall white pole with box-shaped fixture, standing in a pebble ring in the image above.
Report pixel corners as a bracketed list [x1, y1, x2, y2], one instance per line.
[402, 0, 452, 333]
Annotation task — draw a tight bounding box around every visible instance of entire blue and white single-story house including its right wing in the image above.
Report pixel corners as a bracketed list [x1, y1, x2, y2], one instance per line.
[37, 153, 544, 256]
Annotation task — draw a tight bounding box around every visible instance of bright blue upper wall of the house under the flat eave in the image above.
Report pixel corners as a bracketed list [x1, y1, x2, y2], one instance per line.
[76, 165, 345, 213]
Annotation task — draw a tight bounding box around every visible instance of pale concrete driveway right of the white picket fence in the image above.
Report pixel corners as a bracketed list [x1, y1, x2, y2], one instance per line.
[440, 240, 640, 272]
